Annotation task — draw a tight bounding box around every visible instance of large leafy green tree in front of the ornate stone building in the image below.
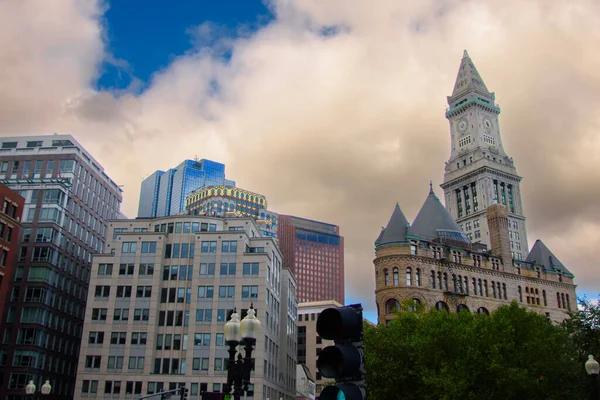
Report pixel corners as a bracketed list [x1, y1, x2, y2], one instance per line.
[365, 302, 586, 400]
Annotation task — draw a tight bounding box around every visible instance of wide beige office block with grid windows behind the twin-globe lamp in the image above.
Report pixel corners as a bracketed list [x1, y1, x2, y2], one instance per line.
[75, 215, 296, 400]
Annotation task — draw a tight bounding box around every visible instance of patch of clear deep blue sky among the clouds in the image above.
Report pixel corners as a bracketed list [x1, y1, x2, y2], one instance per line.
[96, 0, 274, 89]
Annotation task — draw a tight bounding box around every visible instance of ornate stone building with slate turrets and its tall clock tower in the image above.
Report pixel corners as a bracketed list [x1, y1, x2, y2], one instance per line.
[374, 51, 577, 324]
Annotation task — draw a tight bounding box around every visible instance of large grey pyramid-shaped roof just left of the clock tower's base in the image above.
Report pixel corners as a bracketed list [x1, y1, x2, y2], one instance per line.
[408, 185, 470, 243]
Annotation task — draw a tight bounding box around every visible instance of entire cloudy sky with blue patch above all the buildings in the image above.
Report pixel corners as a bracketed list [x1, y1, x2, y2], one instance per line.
[0, 0, 600, 315]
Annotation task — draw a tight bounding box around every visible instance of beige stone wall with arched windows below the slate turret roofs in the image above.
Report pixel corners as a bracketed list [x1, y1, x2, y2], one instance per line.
[374, 244, 577, 324]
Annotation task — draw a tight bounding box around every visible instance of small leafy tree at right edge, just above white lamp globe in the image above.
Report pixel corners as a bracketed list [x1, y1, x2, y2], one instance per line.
[563, 296, 600, 363]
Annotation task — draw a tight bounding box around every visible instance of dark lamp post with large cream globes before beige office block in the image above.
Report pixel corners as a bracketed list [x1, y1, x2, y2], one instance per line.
[224, 304, 260, 400]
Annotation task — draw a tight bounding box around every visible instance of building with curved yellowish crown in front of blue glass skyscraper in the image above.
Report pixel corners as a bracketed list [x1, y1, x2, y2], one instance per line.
[185, 185, 277, 237]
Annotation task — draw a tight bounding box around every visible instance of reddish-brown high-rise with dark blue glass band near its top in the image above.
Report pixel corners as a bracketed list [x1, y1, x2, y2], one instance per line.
[277, 215, 344, 304]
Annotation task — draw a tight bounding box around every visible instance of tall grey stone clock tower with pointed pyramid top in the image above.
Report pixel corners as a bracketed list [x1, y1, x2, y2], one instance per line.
[441, 50, 528, 260]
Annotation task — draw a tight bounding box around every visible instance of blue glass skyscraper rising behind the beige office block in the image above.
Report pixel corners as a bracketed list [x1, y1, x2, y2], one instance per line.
[138, 159, 235, 218]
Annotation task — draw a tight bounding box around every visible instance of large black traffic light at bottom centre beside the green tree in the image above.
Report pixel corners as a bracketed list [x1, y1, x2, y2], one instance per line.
[317, 304, 367, 400]
